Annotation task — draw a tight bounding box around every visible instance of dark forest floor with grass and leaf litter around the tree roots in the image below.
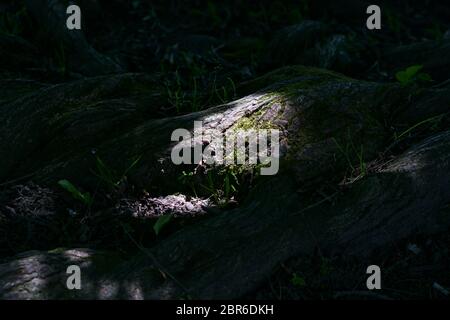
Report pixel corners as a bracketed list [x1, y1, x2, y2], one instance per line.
[0, 0, 450, 299]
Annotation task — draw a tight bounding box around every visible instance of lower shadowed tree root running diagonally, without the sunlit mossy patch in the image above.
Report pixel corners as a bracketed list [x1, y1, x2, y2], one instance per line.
[0, 128, 450, 299]
